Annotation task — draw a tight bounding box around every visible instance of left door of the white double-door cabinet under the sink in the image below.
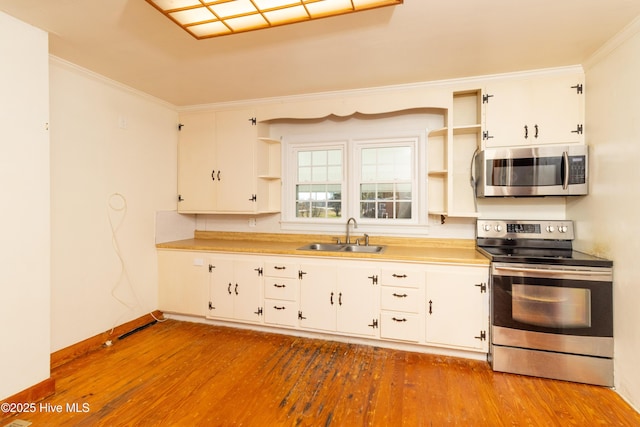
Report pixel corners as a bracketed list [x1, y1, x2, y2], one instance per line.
[300, 264, 338, 331]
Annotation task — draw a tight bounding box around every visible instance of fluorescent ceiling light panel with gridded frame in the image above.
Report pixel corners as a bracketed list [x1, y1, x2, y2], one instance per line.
[146, 0, 404, 39]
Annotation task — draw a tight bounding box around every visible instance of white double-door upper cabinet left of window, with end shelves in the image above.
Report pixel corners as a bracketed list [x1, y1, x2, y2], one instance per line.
[178, 110, 280, 214]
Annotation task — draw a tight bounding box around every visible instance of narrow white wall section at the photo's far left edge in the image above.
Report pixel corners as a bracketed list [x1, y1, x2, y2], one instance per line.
[0, 12, 50, 400]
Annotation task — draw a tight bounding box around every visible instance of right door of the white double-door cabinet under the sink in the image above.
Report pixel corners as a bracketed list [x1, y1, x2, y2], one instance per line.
[336, 266, 380, 336]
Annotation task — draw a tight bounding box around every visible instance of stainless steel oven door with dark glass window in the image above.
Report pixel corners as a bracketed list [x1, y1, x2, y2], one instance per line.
[492, 263, 613, 357]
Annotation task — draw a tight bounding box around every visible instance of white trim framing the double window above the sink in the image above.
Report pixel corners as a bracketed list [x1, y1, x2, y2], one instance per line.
[280, 129, 429, 236]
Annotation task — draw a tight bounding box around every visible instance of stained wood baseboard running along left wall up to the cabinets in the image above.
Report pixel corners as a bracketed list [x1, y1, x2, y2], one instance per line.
[51, 310, 163, 369]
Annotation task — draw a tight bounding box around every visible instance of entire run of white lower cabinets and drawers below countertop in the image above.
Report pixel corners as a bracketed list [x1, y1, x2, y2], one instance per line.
[158, 250, 489, 353]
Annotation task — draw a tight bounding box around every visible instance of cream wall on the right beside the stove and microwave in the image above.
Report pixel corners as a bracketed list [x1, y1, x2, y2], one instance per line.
[567, 20, 640, 408]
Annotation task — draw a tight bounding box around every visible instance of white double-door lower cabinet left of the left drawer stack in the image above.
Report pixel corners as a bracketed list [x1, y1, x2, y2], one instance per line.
[207, 256, 263, 323]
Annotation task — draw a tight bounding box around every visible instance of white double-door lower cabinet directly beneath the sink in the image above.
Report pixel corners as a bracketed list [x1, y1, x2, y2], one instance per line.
[300, 260, 380, 337]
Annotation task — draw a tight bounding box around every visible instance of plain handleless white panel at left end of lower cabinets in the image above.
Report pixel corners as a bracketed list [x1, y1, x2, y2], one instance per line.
[158, 251, 209, 316]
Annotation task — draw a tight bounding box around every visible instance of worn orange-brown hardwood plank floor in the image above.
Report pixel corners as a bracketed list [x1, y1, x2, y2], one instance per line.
[0, 320, 640, 426]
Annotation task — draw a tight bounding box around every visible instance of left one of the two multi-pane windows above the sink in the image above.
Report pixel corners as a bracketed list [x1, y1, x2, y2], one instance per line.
[295, 148, 343, 218]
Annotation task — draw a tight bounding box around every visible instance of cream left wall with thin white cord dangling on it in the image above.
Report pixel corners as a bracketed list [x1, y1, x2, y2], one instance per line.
[50, 58, 177, 351]
